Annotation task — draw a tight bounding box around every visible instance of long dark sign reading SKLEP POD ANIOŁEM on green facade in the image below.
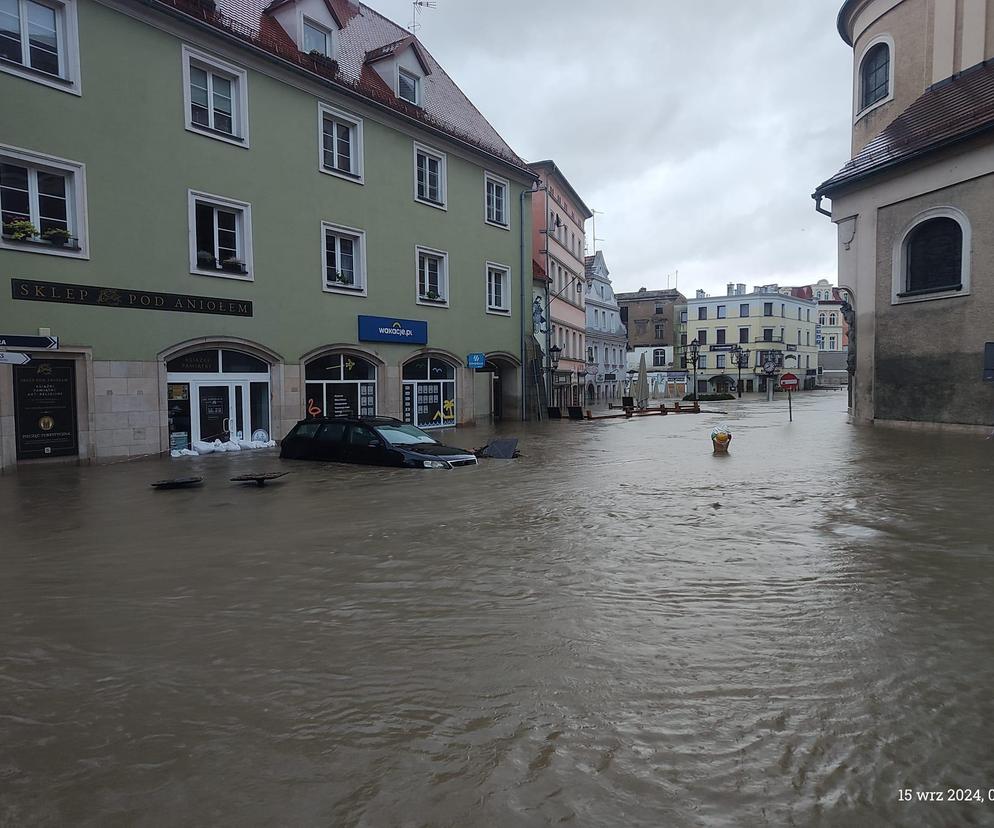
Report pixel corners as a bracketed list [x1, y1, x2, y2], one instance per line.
[10, 279, 252, 316]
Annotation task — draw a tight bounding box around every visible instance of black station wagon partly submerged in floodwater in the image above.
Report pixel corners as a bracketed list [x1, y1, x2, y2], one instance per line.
[280, 417, 476, 469]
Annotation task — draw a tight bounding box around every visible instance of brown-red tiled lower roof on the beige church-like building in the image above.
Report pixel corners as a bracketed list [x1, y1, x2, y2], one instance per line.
[813, 62, 994, 198]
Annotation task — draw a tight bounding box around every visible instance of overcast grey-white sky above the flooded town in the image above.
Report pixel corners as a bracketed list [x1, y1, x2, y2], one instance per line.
[366, 0, 852, 295]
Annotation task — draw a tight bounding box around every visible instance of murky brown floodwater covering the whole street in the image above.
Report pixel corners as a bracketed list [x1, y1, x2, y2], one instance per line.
[0, 392, 994, 826]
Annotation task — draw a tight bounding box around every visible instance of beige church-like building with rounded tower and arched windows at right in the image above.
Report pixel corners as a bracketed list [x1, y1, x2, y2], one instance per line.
[814, 0, 994, 430]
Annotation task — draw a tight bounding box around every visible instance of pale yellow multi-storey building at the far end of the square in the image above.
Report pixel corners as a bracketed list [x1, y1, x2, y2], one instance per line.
[680, 284, 818, 394]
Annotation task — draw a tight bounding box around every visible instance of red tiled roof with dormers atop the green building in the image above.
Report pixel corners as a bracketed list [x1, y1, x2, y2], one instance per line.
[155, 0, 527, 172]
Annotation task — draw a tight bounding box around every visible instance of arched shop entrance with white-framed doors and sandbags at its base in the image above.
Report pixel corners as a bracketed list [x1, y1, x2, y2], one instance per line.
[166, 348, 272, 451]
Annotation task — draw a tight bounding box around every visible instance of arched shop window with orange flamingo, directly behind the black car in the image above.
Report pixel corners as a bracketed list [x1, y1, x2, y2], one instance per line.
[304, 353, 376, 419]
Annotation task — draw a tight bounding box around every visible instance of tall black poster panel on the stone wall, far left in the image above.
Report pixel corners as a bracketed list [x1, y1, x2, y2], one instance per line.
[14, 359, 79, 460]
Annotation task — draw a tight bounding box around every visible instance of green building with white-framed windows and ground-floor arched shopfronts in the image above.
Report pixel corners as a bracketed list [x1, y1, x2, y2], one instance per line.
[0, 0, 533, 468]
